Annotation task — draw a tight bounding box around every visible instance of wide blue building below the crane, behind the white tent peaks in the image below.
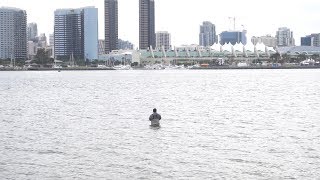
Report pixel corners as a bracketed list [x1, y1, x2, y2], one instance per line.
[220, 30, 247, 45]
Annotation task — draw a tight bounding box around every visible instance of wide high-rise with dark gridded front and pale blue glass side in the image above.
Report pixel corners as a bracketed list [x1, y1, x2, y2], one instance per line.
[54, 7, 98, 60]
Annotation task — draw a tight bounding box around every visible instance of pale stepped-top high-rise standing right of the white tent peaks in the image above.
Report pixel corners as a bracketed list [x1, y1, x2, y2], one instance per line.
[276, 27, 295, 46]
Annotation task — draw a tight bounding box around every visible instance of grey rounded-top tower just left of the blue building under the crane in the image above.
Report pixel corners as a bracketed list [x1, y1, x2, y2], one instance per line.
[199, 21, 218, 46]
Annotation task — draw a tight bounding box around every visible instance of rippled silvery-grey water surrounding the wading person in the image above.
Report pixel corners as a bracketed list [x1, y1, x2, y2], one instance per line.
[0, 70, 320, 179]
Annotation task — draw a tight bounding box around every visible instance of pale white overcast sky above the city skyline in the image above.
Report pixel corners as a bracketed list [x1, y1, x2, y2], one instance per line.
[0, 0, 320, 46]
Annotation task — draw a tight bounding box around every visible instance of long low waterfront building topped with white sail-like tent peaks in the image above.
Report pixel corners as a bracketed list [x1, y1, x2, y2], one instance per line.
[139, 41, 276, 65]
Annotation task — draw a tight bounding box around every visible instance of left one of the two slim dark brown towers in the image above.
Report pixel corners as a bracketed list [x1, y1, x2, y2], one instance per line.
[104, 0, 118, 54]
